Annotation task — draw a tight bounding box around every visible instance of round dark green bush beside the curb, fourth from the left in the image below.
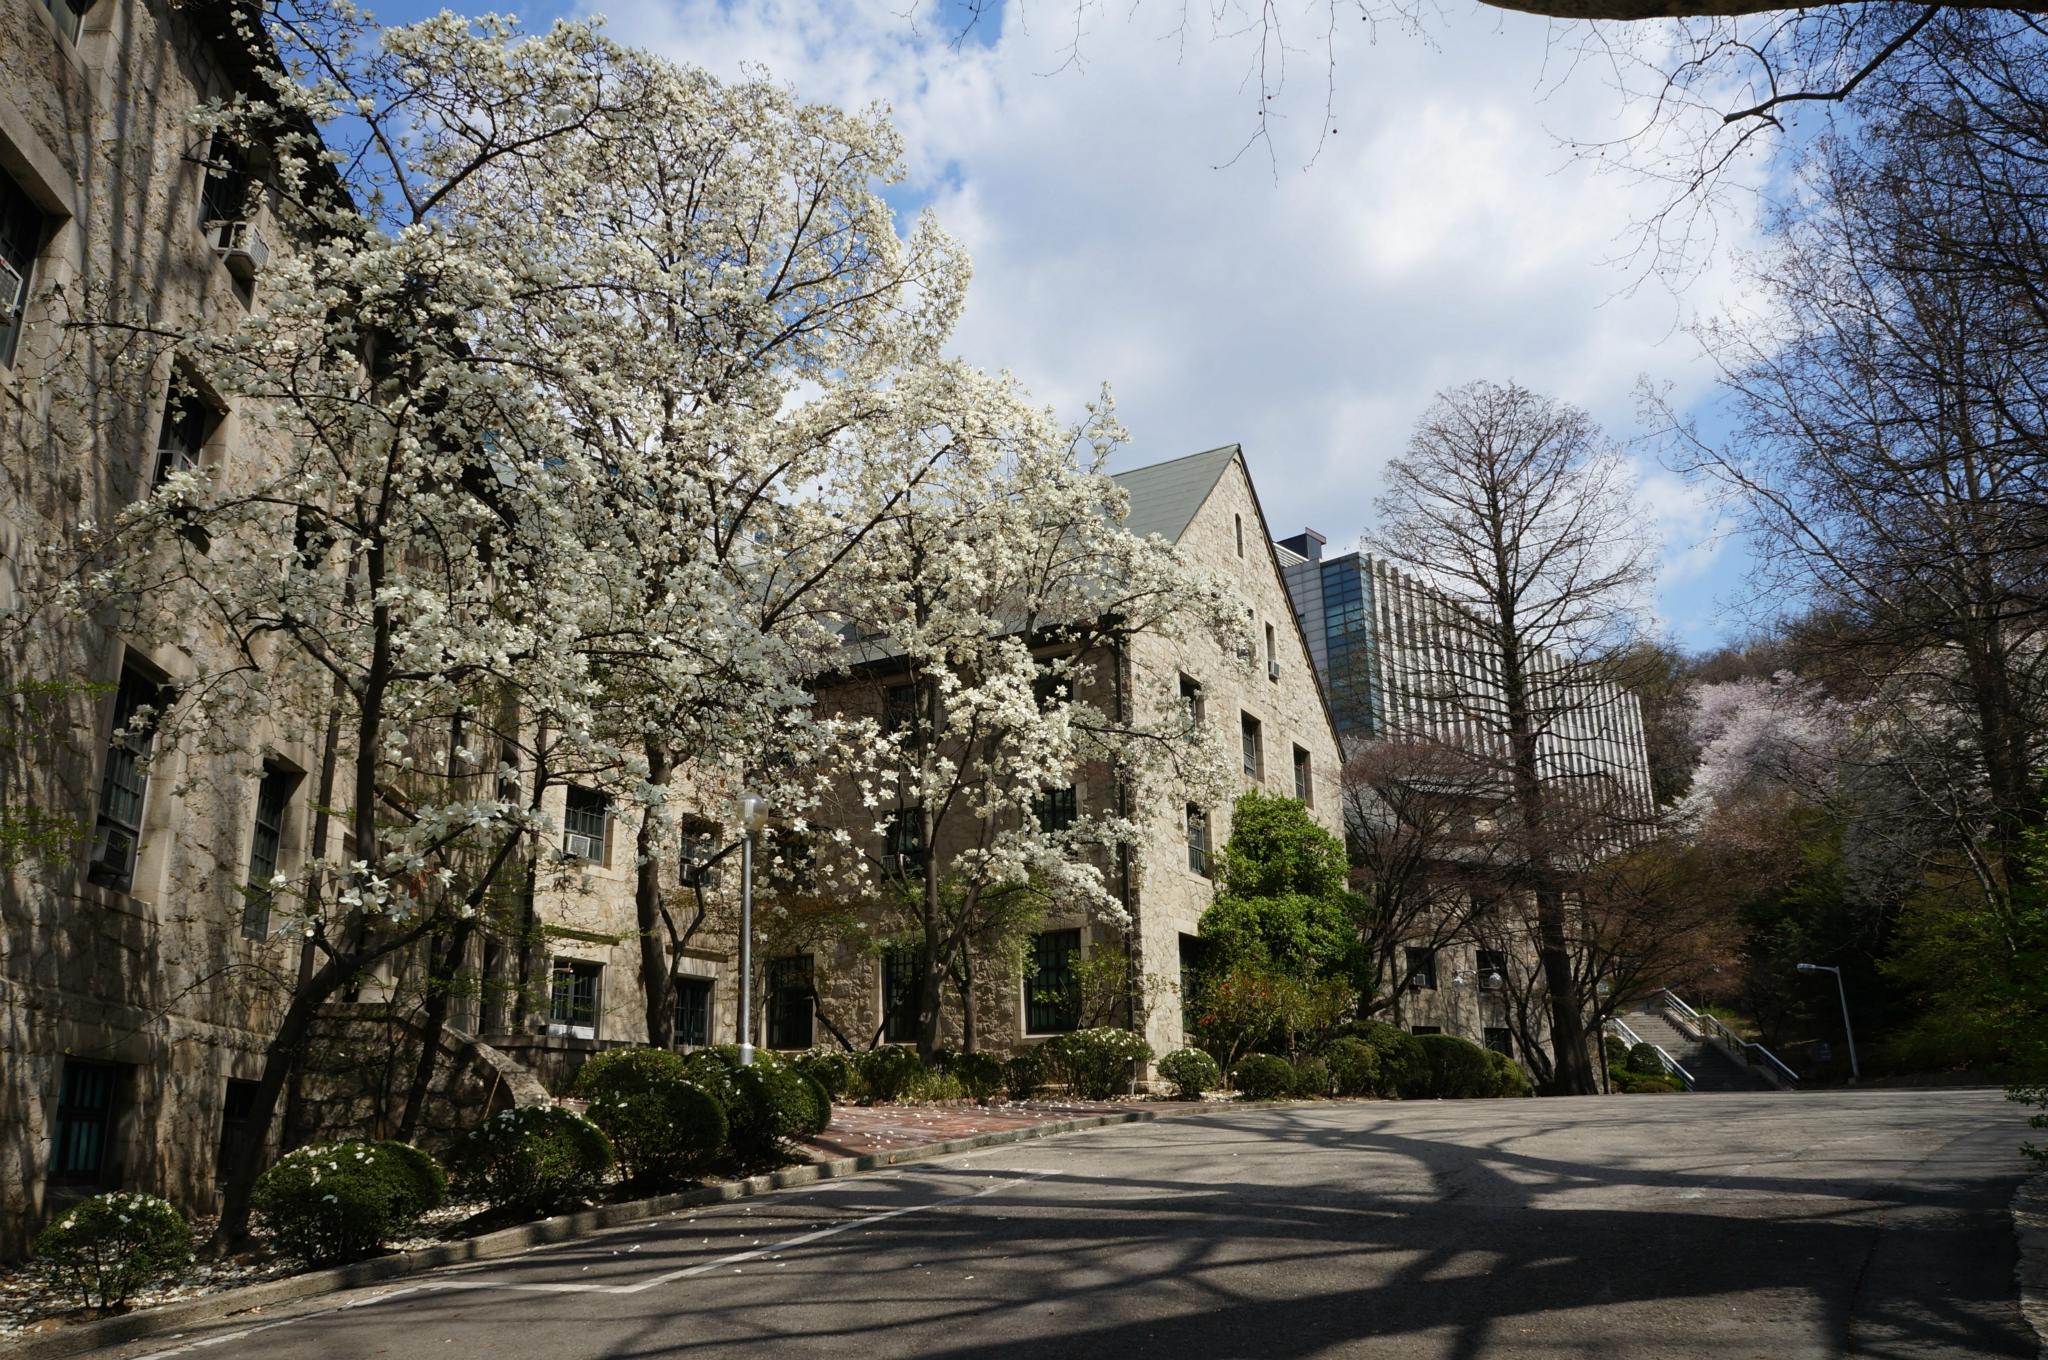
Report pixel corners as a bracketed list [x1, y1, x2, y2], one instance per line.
[575, 1049, 727, 1186]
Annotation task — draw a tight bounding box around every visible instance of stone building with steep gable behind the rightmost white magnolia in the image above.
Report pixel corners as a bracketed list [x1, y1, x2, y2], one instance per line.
[760, 444, 1341, 1055]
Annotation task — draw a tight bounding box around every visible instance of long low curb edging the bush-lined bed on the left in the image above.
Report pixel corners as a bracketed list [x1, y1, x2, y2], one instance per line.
[12, 1110, 1176, 1360]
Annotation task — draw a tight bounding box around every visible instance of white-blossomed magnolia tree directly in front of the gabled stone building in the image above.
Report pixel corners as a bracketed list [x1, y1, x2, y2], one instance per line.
[819, 387, 1243, 1053]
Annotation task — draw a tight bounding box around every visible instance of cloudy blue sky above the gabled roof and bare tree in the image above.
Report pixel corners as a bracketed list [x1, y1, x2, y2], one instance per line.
[377, 0, 1777, 647]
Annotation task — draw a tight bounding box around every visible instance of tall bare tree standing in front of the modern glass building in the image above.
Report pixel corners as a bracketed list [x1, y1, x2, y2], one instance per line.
[1372, 383, 1651, 1094]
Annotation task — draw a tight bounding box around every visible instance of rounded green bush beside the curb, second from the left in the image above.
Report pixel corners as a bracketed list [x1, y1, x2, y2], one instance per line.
[252, 1141, 446, 1266]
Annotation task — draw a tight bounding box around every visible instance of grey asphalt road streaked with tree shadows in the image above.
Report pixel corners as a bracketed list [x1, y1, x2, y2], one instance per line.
[119, 1092, 2038, 1360]
